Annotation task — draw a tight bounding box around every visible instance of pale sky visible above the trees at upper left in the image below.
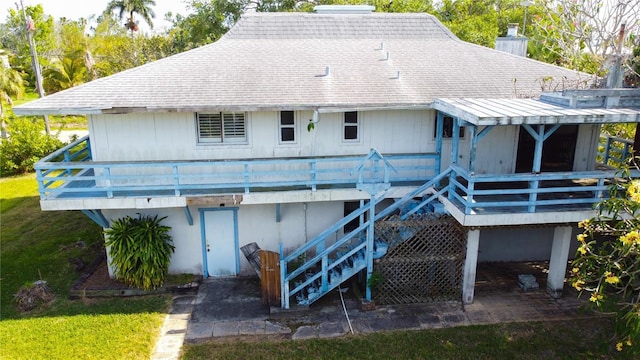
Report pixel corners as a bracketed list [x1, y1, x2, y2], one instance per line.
[0, 0, 188, 32]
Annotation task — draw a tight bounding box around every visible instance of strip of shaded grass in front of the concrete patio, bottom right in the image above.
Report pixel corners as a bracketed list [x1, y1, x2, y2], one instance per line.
[182, 318, 631, 360]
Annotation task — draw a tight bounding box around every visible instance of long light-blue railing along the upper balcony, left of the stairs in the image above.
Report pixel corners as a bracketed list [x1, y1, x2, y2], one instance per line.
[35, 137, 438, 200]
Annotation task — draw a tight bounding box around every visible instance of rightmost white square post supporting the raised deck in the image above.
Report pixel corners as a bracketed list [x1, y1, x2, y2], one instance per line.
[547, 226, 572, 299]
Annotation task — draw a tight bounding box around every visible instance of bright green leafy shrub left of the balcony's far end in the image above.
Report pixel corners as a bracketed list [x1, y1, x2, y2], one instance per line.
[0, 118, 64, 176]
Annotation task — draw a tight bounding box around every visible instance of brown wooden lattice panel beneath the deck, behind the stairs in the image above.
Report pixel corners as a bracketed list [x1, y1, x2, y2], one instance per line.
[373, 213, 466, 304]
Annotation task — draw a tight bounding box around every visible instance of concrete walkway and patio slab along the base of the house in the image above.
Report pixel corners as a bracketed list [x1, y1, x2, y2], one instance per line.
[153, 262, 588, 359]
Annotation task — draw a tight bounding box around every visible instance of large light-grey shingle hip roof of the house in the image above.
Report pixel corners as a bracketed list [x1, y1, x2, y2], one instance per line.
[14, 13, 584, 114]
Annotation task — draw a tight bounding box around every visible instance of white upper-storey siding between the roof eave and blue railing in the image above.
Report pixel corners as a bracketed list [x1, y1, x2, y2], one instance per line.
[89, 110, 435, 161]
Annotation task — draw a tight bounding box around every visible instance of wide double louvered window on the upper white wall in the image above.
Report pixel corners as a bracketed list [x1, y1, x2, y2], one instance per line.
[196, 113, 247, 143]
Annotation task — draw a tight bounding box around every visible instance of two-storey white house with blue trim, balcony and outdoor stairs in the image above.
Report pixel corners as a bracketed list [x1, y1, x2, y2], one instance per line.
[14, 6, 640, 307]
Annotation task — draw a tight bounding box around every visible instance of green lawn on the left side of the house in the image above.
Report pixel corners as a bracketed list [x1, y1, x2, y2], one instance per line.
[0, 175, 170, 359]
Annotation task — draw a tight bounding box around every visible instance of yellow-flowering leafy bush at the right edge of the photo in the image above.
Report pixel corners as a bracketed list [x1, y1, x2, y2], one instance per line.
[571, 168, 640, 356]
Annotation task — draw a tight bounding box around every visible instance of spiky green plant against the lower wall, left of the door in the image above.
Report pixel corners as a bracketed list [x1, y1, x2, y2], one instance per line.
[105, 214, 175, 290]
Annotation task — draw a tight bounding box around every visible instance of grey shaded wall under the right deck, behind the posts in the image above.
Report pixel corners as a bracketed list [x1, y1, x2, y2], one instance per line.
[478, 227, 578, 262]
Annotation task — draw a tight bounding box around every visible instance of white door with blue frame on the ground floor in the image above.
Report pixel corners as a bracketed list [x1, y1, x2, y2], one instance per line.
[203, 209, 238, 276]
